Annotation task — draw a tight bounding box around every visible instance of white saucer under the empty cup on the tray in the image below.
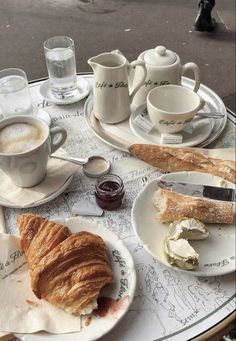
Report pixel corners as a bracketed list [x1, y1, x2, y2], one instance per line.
[129, 104, 214, 147]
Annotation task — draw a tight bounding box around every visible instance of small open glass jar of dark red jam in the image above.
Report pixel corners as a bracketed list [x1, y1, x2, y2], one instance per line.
[95, 174, 125, 211]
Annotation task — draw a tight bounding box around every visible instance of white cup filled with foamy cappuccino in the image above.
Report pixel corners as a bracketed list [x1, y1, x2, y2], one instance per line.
[0, 115, 67, 187]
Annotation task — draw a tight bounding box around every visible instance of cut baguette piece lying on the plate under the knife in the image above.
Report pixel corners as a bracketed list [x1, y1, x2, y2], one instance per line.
[152, 188, 233, 224]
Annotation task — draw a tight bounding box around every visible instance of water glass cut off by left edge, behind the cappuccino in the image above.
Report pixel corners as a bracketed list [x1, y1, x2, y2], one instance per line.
[0, 68, 33, 117]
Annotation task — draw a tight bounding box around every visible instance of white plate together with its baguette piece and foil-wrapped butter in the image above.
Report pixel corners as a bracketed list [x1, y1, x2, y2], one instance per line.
[131, 171, 235, 276]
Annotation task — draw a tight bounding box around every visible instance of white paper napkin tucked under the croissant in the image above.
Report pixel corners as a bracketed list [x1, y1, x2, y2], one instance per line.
[0, 233, 81, 335]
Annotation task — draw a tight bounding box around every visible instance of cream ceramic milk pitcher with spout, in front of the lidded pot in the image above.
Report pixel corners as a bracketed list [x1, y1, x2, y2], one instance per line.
[88, 50, 146, 123]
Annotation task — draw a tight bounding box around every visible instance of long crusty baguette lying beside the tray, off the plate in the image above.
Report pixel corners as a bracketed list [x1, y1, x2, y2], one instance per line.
[129, 144, 236, 183]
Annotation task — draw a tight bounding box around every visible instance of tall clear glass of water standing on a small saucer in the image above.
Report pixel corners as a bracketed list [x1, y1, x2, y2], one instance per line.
[43, 36, 78, 99]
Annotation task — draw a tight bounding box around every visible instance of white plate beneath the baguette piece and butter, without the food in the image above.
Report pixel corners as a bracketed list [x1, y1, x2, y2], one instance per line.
[131, 172, 235, 276]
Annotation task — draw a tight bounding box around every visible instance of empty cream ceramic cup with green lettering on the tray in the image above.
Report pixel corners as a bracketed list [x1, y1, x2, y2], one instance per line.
[147, 85, 205, 133]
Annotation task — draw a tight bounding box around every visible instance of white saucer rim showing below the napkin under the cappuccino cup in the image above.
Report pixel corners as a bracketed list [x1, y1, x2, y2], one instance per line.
[0, 174, 73, 208]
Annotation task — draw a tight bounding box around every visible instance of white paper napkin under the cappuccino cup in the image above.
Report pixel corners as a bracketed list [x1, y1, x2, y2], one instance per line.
[0, 158, 81, 207]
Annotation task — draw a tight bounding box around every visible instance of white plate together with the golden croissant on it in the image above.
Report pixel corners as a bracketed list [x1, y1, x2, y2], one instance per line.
[12, 214, 136, 341]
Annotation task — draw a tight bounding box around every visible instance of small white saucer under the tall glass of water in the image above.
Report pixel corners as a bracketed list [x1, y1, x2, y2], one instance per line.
[39, 76, 90, 105]
